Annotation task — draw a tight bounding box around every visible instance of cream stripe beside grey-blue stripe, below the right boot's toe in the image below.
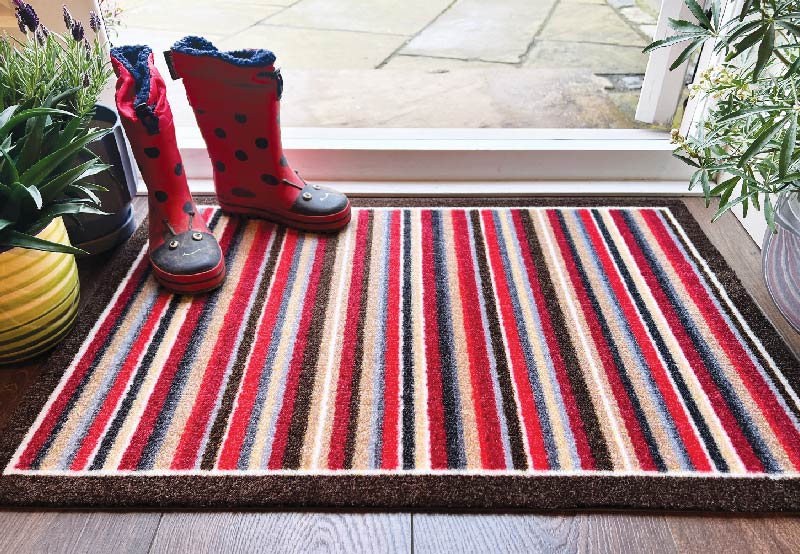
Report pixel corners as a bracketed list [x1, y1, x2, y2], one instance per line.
[246, 235, 318, 469]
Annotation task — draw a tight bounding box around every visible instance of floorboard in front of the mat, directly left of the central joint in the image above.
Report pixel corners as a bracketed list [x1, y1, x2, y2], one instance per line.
[150, 512, 411, 554]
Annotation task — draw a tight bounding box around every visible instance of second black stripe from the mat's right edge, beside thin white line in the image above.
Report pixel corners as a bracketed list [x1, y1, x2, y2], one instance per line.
[592, 210, 730, 471]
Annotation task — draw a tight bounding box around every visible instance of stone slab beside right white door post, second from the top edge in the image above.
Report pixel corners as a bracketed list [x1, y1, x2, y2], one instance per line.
[523, 40, 647, 73]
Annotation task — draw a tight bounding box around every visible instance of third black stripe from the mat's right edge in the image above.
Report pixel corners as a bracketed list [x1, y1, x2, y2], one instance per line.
[555, 211, 667, 471]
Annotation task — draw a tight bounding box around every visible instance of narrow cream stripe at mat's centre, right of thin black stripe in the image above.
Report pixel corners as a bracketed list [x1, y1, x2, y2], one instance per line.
[410, 210, 433, 469]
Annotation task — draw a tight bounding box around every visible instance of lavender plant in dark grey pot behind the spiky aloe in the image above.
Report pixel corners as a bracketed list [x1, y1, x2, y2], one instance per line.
[0, 0, 136, 254]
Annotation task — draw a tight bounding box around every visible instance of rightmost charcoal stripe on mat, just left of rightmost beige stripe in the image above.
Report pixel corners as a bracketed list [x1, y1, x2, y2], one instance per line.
[621, 211, 780, 473]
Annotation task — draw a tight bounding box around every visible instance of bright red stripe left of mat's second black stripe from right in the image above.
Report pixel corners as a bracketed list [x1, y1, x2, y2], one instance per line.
[580, 210, 711, 471]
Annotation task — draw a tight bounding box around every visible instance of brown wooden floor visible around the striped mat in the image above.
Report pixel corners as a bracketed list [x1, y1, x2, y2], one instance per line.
[0, 198, 800, 554]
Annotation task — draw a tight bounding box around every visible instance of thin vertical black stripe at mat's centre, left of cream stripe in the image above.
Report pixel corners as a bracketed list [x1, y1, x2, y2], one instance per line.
[402, 210, 414, 469]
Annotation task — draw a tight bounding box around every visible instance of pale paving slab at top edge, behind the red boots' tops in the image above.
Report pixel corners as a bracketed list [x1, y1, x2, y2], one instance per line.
[117, 0, 284, 35]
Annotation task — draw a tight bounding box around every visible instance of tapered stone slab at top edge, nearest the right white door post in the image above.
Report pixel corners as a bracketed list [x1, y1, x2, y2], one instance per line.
[539, 3, 645, 46]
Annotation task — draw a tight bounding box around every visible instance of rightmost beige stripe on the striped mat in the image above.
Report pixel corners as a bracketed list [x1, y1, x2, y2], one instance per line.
[635, 209, 793, 469]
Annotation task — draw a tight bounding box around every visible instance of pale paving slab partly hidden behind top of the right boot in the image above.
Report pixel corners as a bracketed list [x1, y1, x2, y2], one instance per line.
[218, 25, 405, 69]
